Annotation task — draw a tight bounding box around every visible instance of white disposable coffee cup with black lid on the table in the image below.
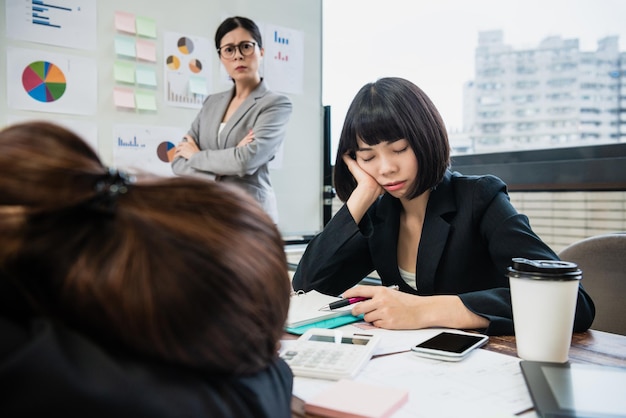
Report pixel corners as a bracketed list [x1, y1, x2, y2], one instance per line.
[508, 258, 582, 363]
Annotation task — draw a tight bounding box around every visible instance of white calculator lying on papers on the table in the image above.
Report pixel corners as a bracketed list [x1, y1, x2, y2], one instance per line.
[280, 328, 381, 380]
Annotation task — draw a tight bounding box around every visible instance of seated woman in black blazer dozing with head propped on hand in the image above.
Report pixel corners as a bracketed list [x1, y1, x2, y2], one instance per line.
[293, 78, 595, 335]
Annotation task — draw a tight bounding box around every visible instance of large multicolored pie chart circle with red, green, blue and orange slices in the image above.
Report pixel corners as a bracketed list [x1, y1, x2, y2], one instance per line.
[22, 61, 67, 103]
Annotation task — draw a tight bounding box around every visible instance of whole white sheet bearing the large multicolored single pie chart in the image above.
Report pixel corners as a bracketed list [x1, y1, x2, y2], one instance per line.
[7, 48, 98, 115]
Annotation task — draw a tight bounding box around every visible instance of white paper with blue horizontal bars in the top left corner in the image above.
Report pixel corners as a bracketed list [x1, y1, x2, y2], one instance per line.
[6, 0, 97, 50]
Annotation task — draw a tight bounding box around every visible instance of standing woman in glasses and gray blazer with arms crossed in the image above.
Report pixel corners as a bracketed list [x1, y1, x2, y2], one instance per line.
[172, 16, 292, 223]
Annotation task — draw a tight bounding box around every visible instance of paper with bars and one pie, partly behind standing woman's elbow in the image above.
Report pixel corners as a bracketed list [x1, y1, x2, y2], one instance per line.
[113, 125, 186, 177]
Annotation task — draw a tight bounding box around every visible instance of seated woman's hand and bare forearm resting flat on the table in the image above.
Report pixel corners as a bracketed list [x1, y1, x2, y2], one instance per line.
[342, 286, 489, 329]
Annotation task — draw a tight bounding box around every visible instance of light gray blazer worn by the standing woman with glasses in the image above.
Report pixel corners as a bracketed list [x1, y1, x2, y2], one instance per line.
[172, 80, 292, 223]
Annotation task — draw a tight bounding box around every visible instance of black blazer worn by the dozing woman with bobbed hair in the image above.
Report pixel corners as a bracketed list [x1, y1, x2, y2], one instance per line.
[293, 171, 595, 335]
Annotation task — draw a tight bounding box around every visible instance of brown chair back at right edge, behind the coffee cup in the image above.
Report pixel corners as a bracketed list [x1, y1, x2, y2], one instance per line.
[559, 232, 626, 335]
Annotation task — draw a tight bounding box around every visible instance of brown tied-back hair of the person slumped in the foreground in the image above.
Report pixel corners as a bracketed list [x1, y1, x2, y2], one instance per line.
[0, 122, 291, 374]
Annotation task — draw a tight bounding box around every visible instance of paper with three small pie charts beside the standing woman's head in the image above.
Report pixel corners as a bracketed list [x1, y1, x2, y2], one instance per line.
[163, 32, 211, 108]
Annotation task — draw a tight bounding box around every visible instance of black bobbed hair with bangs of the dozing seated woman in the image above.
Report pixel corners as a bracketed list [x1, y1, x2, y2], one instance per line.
[334, 77, 450, 202]
